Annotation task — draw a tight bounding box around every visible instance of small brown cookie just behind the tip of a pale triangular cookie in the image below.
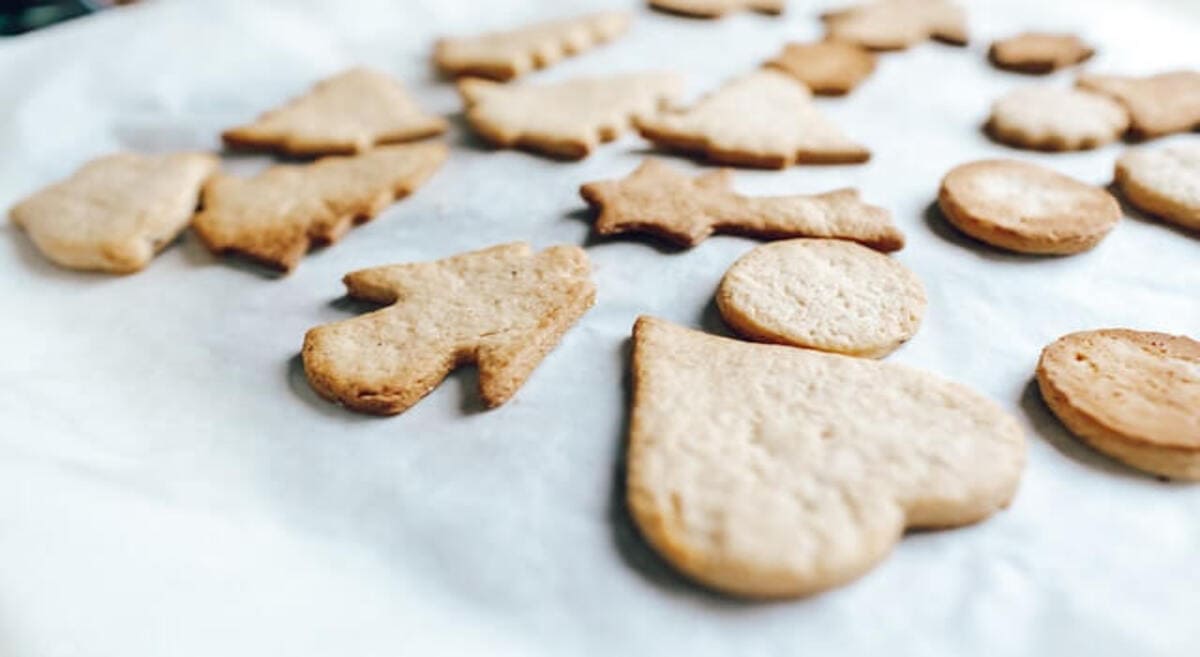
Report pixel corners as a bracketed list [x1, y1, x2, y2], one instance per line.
[764, 41, 875, 96]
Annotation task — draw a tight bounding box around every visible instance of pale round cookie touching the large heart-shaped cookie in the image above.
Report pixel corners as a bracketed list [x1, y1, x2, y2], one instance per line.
[716, 239, 925, 357]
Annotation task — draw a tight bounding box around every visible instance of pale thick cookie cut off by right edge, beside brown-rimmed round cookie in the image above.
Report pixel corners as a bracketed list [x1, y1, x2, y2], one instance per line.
[1116, 140, 1200, 230]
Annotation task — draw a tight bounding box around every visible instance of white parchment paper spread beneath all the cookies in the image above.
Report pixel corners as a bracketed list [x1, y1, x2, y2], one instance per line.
[0, 0, 1200, 657]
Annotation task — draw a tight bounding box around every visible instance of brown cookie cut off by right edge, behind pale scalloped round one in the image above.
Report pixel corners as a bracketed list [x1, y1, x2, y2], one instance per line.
[1078, 71, 1200, 139]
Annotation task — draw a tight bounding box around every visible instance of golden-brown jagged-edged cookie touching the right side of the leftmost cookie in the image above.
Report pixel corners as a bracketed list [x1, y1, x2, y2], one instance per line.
[193, 141, 446, 271]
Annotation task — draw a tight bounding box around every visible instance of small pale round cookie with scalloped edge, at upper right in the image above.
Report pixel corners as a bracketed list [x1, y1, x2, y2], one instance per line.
[986, 86, 1129, 151]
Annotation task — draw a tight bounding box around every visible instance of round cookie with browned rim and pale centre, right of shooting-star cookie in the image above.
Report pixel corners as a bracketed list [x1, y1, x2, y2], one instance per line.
[937, 159, 1121, 255]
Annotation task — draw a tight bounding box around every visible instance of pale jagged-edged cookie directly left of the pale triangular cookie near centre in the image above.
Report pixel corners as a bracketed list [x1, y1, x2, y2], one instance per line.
[458, 73, 683, 159]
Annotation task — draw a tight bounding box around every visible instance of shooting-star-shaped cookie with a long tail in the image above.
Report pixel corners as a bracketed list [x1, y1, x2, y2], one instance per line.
[580, 159, 904, 251]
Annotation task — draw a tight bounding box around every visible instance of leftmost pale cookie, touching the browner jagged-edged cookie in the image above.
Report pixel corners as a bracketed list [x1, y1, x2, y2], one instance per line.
[11, 153, 217, 273]
